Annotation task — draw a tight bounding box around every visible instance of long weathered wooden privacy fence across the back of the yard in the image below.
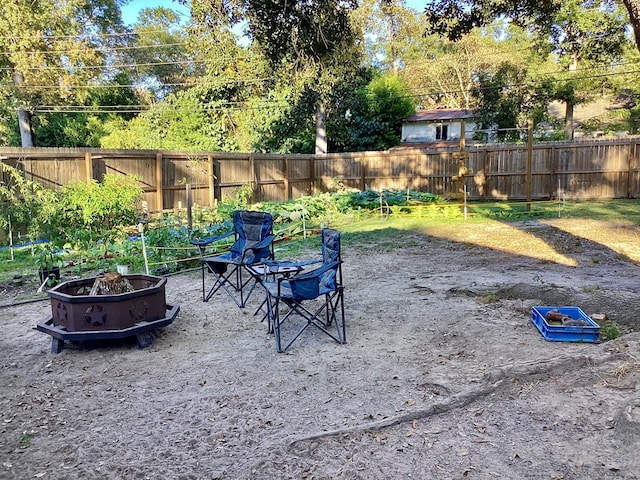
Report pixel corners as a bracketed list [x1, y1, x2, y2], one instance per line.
[0, 136, 640, 211]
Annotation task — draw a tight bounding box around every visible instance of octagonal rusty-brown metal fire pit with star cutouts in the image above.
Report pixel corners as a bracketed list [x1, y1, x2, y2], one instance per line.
[36, 275, 180, 353]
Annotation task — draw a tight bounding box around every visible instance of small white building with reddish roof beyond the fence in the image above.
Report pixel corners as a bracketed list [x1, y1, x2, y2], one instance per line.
[402, 108, 478, 144]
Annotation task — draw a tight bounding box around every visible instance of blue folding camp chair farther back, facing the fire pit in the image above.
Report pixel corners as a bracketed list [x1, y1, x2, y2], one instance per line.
[191, 210, 274, 308]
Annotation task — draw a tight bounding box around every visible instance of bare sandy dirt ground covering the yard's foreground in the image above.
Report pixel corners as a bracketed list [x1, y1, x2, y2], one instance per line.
[0, 219, 640, 480]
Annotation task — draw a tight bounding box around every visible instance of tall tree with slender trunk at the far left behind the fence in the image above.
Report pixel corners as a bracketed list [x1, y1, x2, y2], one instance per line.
[0, 0, 123, 147]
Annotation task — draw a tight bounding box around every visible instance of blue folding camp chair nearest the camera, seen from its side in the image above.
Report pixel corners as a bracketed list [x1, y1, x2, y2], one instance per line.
[263, 228, 347, 352]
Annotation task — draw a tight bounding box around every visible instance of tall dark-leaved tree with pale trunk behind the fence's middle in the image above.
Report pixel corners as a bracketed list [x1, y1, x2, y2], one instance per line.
[191, 0, 360, 153]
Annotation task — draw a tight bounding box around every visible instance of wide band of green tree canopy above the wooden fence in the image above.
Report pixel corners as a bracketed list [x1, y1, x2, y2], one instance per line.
[0, 0, 640, 153]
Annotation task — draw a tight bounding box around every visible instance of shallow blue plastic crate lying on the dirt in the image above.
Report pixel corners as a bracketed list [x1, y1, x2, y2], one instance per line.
[531, 307, 600, 343]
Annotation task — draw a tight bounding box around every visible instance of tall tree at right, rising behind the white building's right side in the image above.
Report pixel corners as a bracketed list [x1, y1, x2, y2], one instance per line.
[425, 0, 627, 138]
